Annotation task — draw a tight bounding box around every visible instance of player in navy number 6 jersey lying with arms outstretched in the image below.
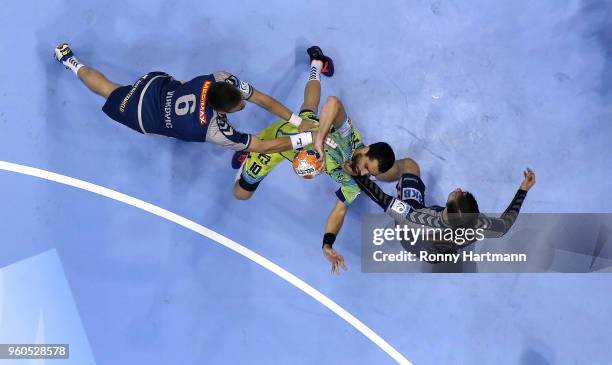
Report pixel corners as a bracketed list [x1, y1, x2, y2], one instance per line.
[54, 43, 317, 153]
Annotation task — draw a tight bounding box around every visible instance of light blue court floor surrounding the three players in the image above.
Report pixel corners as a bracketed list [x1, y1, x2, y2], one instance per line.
[0, 0, 612, 365]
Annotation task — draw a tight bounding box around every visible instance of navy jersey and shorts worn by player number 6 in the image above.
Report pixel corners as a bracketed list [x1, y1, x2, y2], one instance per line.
[103, 72, 253, 150]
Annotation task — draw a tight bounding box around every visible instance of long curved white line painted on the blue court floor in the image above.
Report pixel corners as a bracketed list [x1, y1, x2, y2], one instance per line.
[0, 161, 411, 365]
